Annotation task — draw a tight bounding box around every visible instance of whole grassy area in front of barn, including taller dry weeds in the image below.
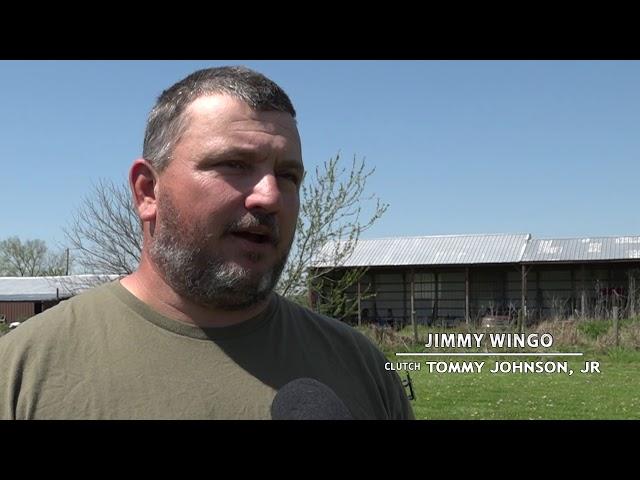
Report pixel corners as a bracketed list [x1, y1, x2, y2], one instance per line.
[369, 319, 640, 420]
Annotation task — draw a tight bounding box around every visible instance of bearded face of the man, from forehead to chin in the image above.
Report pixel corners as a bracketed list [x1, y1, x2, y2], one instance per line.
[149, 95, 303, 310]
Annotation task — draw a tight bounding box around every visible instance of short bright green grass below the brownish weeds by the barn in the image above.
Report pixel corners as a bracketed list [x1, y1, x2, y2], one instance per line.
[389, 355, 640, 419]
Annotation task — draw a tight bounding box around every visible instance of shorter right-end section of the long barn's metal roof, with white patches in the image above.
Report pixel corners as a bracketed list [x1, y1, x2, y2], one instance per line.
[522, 236, 640, 262]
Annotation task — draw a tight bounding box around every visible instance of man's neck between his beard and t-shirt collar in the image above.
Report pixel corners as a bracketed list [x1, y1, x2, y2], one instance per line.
[120, 261, 269, 327]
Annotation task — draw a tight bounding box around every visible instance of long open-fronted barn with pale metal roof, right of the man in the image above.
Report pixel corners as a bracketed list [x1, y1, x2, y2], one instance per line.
[314, 234, 640, 325]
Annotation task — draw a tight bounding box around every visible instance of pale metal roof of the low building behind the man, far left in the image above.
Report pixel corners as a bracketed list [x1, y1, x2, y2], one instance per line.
[0, 275, 120, 302]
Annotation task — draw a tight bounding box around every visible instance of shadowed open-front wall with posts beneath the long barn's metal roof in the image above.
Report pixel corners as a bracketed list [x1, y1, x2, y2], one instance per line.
[322, 262, 640, 325]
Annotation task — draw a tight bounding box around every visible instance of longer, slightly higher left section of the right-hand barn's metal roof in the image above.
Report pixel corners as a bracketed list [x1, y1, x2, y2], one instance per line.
[314, 234, 530, 267]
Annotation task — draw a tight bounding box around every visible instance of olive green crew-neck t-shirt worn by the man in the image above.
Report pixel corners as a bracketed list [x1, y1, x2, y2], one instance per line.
[0, 281, 414, 419]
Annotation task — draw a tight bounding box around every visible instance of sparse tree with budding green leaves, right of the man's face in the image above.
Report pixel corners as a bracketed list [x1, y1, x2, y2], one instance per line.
[277, 154, 388, 319]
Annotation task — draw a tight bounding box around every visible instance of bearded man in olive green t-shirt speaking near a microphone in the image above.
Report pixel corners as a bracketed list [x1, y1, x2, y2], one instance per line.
[0, 67, 413, 419]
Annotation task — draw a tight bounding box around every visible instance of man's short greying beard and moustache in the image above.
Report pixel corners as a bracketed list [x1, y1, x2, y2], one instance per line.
[149, 191, 293, 310]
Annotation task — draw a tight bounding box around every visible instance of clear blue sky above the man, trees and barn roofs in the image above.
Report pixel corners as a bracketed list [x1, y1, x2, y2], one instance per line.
[0, 60, 640, 251]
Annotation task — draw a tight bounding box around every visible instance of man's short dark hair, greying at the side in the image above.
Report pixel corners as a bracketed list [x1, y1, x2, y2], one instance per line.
[142, 66, 296, 171]
